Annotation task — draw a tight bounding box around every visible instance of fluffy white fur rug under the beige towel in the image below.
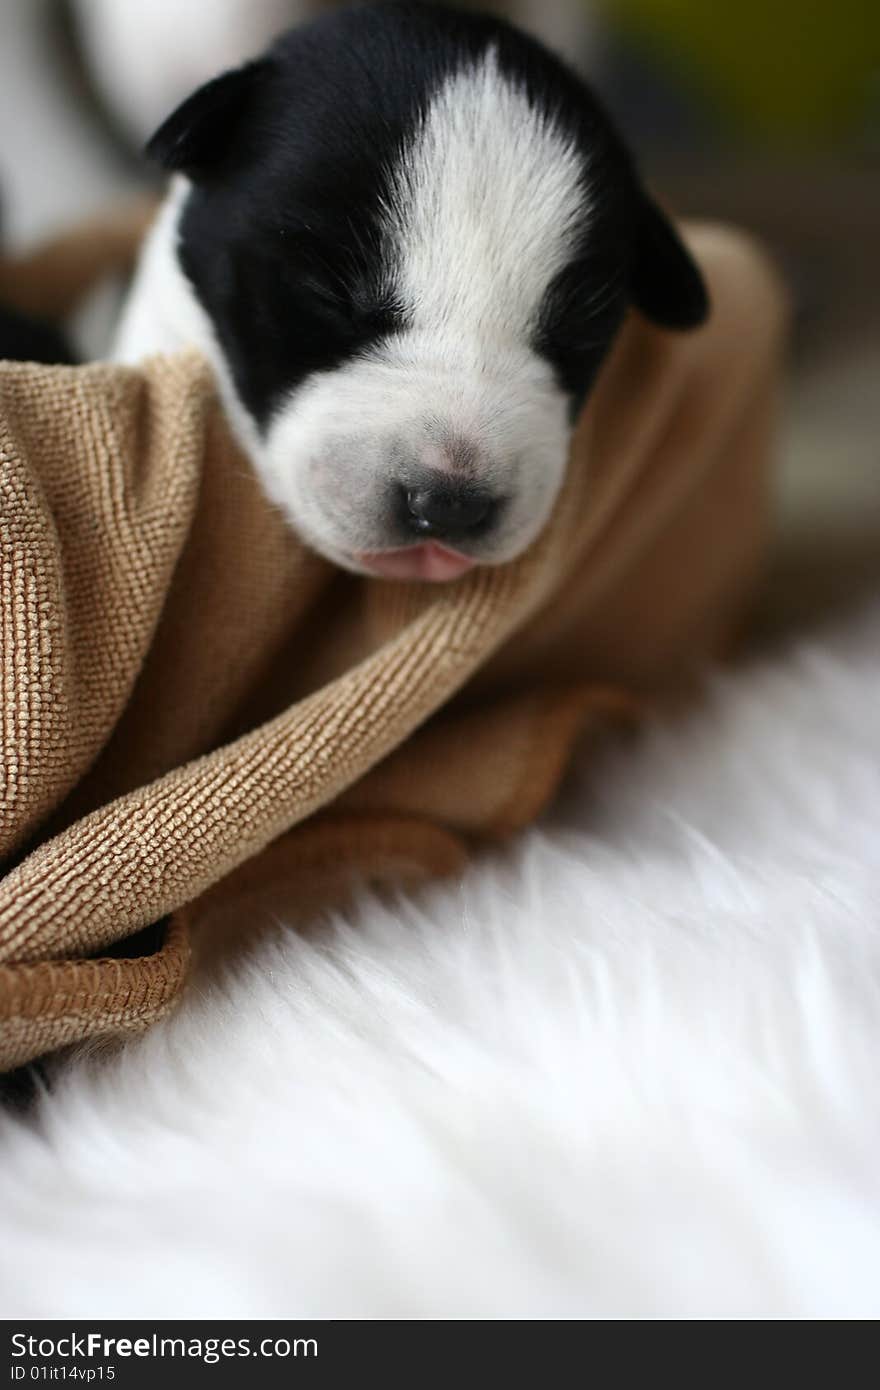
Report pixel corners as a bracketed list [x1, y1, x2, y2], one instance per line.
[0, 606, 880, 1319]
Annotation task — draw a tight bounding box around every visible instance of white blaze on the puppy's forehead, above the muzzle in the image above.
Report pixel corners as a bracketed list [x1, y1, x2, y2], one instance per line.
[386, 50, 587, 364]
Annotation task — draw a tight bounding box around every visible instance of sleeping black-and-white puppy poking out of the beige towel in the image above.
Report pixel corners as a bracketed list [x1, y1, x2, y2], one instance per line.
[117, 3, 706, 580]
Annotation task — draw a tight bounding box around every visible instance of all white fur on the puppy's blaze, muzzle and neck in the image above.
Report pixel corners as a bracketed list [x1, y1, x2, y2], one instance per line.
[115, 51, 588, 570]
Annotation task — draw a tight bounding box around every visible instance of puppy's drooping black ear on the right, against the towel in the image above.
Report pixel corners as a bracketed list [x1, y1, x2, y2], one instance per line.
[631, 195, 709, 328]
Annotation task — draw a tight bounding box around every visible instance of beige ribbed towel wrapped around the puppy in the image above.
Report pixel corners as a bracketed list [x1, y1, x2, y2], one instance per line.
[0, 216, 784, 1066]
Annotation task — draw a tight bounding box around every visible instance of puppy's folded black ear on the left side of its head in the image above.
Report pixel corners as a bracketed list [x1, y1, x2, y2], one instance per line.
[146, 58, 271, 179]
